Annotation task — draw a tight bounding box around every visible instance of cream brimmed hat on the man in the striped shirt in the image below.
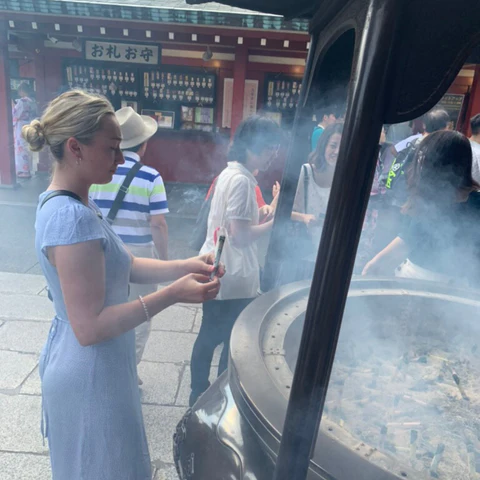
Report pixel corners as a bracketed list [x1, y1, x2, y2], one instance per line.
[115, 107, 158, 150]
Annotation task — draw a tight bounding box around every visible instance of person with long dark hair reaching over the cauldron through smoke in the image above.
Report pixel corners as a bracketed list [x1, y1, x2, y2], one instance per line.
[363, 130, 480, 287]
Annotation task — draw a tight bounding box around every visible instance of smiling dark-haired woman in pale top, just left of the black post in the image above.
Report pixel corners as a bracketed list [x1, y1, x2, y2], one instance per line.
[292, 123, 343, 239]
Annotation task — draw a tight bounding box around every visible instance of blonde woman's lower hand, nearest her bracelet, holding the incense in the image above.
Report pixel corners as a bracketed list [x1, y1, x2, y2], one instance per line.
[168, 273, 220, 303]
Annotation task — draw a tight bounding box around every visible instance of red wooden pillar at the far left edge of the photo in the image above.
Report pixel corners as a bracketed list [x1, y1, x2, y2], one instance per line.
[0, 21, 17, 186]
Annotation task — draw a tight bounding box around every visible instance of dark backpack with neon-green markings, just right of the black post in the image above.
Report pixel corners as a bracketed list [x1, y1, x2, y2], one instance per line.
[382, 139, 420, 207]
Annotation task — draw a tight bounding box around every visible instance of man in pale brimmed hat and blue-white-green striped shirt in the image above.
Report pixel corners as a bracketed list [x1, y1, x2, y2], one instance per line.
[90, 107, 168, 384]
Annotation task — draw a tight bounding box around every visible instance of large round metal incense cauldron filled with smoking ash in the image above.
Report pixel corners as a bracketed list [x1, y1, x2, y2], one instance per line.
[175, 279, 480, 480]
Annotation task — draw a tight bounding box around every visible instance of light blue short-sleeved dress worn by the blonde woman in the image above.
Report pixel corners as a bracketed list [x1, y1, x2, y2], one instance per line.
[35, 192, 151, 480]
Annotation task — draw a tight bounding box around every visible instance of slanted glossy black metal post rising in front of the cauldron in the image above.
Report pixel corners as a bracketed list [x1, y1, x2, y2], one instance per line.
[274, 0, 402, 480]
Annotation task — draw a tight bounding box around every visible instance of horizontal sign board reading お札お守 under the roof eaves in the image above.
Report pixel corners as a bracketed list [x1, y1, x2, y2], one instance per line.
[85, 40, 160, 65]
